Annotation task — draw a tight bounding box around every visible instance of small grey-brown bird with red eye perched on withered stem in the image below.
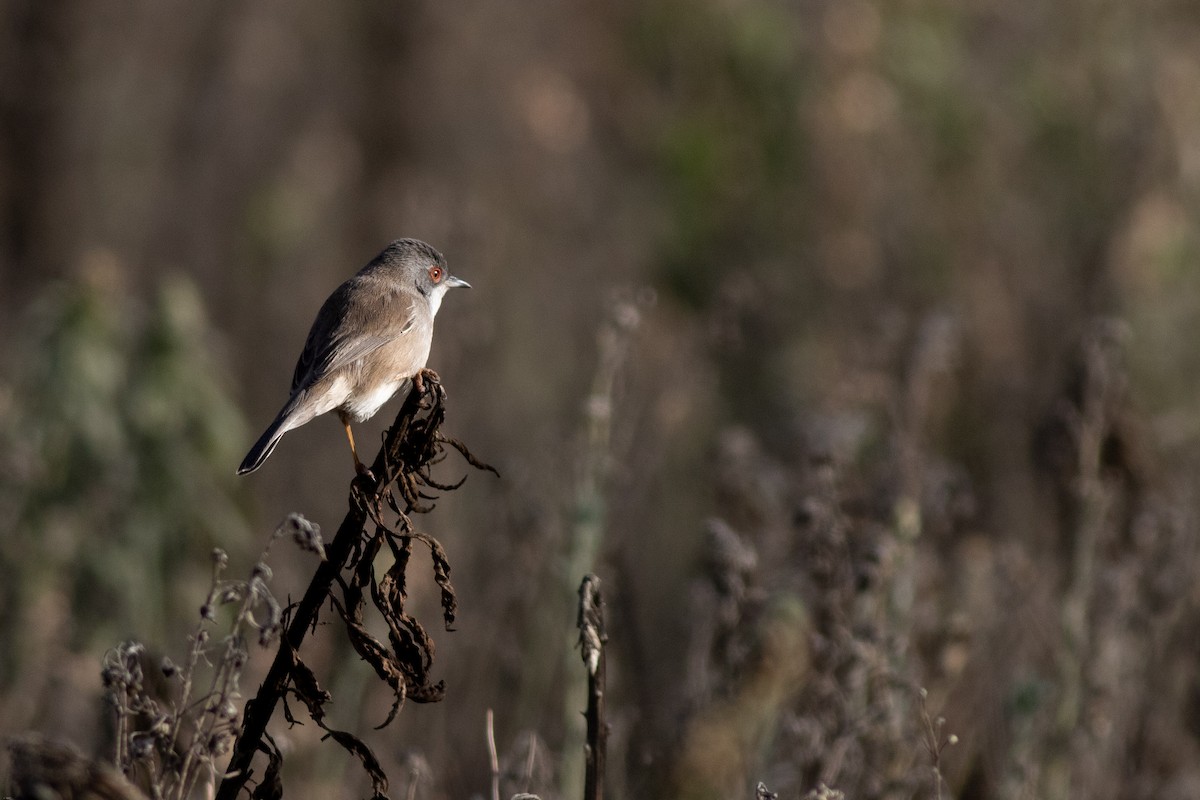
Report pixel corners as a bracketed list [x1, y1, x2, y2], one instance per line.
[238, 239, 470, 475]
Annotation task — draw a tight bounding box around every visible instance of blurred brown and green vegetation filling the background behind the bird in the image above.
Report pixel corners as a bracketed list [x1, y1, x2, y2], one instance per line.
[0, 0, 1200, 800]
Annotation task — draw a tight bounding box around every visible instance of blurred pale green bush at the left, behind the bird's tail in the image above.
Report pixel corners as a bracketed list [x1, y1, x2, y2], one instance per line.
[0, 265, 246, 670]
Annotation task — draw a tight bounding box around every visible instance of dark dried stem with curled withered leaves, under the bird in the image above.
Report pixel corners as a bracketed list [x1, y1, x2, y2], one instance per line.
[216, 371, 496, 800]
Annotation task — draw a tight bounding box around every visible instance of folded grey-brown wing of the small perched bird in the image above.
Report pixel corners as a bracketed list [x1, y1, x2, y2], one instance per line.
[292, 278, 416, 393]
